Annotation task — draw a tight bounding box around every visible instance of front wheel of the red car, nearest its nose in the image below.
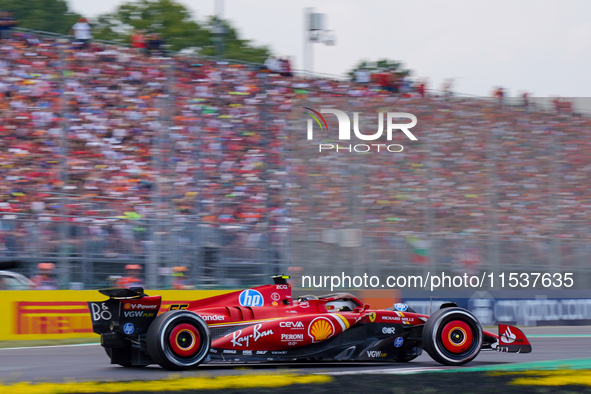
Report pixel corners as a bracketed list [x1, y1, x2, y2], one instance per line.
[423, 308, 484, 365]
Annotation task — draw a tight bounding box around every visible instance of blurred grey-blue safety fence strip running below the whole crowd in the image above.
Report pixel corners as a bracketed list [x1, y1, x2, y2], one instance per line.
[0, 214, 591, 289]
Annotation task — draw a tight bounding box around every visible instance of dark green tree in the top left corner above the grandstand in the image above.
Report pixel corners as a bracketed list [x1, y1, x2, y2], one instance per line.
[0, 0, 80, 34]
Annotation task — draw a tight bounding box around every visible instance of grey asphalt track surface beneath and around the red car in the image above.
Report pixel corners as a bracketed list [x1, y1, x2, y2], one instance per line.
[0, 326, 591, 384]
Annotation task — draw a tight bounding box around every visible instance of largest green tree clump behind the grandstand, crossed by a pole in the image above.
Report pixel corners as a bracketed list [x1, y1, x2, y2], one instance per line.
[93, 0, 270, 62]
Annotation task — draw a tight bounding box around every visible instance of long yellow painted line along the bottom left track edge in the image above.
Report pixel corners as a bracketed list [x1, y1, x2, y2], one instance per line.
[0, 374, 333, 394]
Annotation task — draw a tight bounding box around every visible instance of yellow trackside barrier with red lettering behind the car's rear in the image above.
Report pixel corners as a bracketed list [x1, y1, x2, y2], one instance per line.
[0, 290, 228, 341]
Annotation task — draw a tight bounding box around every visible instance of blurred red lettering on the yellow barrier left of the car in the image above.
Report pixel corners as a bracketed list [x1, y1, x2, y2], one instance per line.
[14, 301, 92, 335]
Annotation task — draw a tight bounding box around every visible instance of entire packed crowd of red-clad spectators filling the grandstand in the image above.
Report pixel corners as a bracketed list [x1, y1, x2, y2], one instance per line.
[0, 29, 591, 270]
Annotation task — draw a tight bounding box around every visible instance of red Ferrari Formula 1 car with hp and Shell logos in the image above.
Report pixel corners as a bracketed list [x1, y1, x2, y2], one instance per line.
[88, 276, 531, 370]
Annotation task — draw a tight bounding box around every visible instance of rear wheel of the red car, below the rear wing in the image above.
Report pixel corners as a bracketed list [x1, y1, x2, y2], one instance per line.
[146, 310, 211, 371]
